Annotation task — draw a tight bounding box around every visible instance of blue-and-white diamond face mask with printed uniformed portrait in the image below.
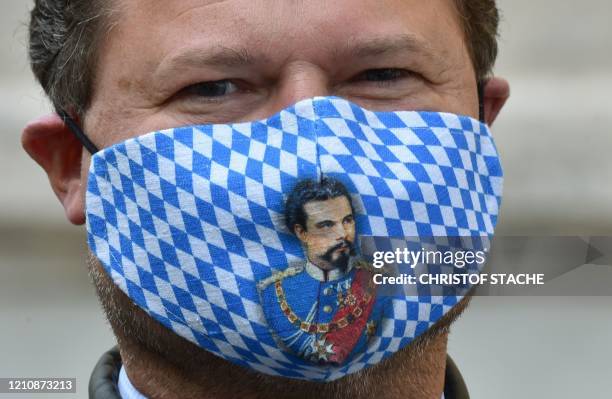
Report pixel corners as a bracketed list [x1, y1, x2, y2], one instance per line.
[77, 97, 502, 381]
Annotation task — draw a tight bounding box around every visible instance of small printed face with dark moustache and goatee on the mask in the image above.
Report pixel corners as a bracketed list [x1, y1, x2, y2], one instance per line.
[296, 196, 355, 270]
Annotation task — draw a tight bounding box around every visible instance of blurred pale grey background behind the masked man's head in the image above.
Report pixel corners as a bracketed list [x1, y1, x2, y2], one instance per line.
[0, 0, 612, 399]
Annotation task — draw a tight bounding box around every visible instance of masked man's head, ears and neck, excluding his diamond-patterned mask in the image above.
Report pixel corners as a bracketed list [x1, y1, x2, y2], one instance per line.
[22, 0, 509, 399]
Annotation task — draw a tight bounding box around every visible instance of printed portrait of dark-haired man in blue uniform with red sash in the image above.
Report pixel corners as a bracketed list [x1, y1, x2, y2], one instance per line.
[258, 177, 382, 364]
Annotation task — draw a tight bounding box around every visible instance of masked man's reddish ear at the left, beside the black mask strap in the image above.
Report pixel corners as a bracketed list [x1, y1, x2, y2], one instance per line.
[21, 114, 85, 225]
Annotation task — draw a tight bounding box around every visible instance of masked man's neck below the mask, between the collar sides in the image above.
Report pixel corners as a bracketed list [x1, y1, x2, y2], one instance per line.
[119, 333, 447, 399]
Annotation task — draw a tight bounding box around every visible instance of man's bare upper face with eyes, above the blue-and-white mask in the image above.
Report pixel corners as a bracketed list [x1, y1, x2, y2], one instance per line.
[83, 0, 478, 153]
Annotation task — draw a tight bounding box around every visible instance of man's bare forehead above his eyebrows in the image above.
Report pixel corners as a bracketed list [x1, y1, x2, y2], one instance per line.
[111, 0, 462, 69]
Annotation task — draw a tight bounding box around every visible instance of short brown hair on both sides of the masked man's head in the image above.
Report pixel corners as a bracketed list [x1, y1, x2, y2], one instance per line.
[29, 0, 499, 116]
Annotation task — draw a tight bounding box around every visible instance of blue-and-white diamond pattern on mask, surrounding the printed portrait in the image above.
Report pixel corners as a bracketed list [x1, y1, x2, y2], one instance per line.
[87, 98, 502, 381]
